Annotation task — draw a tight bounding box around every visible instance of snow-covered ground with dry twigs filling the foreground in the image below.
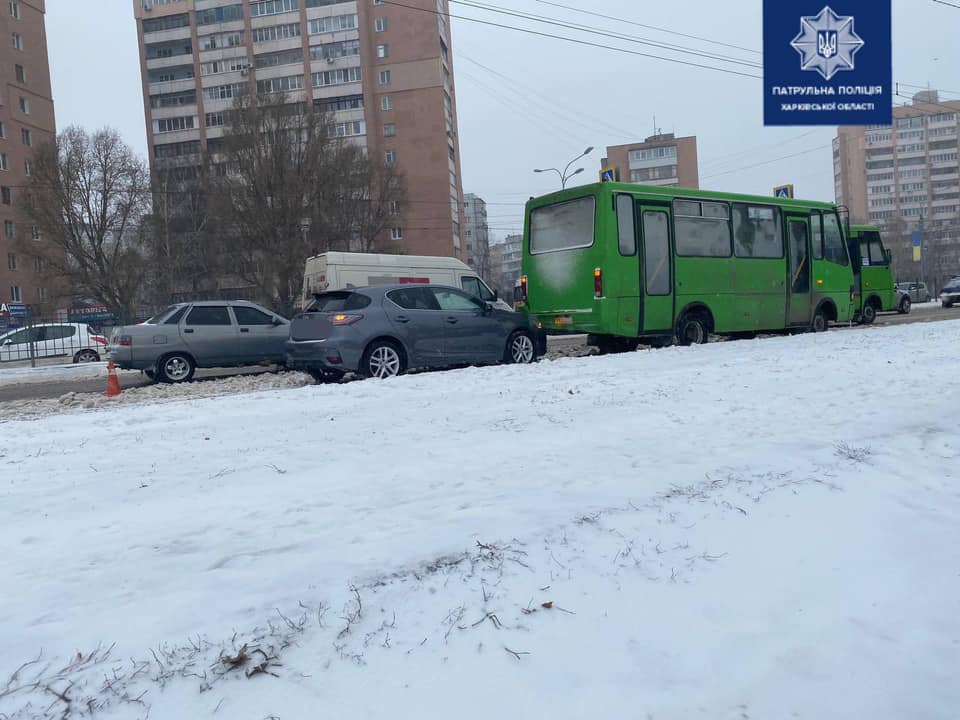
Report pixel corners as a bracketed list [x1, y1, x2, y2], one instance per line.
[0, 321, 960, 720]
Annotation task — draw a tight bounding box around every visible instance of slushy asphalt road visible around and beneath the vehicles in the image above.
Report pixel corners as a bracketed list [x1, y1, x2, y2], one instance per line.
[0, 307, 960, 402]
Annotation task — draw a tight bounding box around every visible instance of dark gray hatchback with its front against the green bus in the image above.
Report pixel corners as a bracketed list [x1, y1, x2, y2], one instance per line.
[287, 285, 546, 380]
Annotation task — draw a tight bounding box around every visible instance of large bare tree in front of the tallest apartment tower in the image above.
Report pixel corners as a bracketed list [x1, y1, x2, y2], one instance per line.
[212, 93, 403, 314]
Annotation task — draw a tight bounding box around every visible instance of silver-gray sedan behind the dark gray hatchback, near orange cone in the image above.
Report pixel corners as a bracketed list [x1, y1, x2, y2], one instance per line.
[107, 300, 290, 383]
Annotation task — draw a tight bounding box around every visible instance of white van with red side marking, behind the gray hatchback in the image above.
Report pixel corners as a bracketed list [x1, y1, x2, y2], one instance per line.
[303, 252, 513, 310]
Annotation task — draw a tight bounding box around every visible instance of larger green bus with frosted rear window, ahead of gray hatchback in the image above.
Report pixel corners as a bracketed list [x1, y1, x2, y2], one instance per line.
[520, 183, 859, 352]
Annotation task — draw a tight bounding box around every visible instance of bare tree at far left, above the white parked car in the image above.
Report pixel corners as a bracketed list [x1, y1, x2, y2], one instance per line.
[23, 127, 149, 322]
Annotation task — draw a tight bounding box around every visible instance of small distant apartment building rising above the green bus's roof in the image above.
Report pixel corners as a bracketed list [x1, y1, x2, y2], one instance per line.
[601, 133, 700, 189]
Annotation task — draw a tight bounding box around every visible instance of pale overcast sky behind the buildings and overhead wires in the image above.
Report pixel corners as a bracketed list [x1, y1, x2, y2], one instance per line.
[47, 0, 960, 238]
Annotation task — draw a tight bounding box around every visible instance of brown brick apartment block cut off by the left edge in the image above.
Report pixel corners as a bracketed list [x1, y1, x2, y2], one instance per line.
[0, 0, 56, 320]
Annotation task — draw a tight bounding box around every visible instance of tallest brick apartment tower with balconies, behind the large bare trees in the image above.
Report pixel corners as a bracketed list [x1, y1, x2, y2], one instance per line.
[134, 0, 465, 257]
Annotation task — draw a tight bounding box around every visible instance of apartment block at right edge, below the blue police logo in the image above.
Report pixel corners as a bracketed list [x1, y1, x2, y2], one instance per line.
[833, 90, 960, 287]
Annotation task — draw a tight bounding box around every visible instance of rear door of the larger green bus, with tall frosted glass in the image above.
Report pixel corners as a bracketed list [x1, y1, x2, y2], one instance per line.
[639, 204, 674, 333]
